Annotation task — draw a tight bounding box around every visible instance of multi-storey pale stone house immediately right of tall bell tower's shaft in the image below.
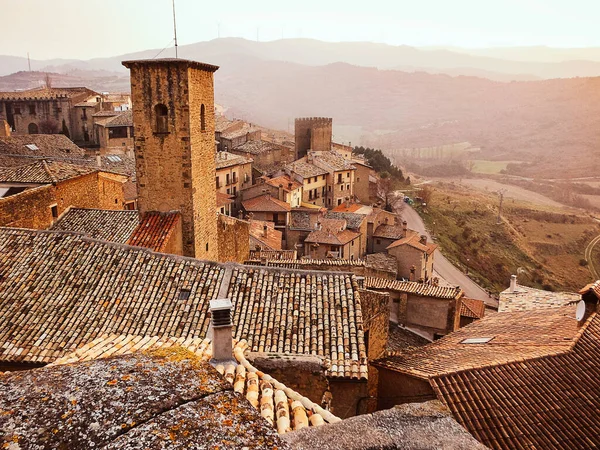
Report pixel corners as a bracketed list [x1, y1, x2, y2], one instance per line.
[215, 152, 252, 216]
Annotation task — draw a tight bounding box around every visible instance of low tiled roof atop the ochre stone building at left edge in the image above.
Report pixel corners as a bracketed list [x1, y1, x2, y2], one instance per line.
[0, 160, 98, 184]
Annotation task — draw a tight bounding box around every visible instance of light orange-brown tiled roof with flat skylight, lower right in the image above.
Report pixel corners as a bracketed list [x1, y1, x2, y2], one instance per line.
[373, 306, 579, 379]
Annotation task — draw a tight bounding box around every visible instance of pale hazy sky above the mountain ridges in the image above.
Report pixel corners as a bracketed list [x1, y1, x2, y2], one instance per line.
[0, 0, 600, 59]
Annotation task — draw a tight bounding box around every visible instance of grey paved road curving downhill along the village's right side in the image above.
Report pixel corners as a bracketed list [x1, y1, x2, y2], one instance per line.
[400, 204, 500, 308]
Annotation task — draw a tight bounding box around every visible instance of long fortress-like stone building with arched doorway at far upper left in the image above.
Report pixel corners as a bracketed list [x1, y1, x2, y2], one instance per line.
[0, 87, 102, 145]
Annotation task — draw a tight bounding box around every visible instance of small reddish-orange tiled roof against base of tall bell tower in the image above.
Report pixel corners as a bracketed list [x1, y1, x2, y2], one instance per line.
[127, 211, 181, 252]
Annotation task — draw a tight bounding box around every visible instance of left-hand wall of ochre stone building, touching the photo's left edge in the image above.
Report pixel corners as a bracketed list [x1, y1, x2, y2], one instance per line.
[0, 185, 56, 230]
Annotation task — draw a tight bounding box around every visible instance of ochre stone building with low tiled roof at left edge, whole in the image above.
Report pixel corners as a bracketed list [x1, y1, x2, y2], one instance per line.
[0, 160, 127, 229]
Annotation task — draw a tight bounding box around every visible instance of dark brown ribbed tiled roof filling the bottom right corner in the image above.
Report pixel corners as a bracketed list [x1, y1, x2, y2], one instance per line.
[430, 309, 600, 449]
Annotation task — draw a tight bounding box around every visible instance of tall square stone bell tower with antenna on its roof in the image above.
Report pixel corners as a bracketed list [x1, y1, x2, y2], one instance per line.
[123, 59, 219, 260]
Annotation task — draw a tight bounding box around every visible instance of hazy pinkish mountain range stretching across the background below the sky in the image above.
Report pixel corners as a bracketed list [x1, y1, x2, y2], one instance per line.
[0, 39, 600, 176]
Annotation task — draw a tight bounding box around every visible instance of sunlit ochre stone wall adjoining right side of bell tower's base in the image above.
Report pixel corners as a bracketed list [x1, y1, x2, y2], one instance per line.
[218, 215, 250, 263]
